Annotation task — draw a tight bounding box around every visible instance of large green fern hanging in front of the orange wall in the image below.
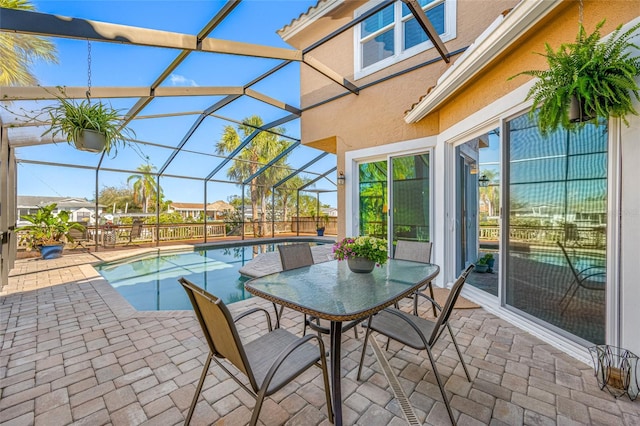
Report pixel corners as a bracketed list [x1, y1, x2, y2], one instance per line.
[511, 20, 640, 135]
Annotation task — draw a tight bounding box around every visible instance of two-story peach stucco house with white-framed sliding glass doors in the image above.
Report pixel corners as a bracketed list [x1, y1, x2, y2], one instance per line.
[278, 0, 640, 361]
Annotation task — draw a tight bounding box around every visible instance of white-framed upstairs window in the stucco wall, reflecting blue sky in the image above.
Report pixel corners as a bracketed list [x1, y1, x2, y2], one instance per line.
[355, 0, 456, 79]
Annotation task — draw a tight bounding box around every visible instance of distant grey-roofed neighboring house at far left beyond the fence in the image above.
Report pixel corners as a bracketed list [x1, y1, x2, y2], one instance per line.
[17, 195, 104, 226]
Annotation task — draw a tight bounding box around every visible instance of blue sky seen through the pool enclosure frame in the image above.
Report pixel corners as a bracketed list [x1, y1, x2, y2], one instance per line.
[7, 0, 335, 205]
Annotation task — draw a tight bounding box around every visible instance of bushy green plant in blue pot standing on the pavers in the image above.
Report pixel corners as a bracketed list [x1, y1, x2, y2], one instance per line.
[18, 203, 84, 259]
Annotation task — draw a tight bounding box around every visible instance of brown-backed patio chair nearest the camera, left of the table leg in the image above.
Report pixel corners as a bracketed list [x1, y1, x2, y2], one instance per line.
[178, 277, 333, 426]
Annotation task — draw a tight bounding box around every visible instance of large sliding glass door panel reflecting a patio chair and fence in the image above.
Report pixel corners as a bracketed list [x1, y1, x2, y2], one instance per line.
[503, 114, 607, 344]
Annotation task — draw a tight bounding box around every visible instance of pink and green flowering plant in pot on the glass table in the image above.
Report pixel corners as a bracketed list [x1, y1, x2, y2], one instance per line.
[333, 236, 387, 273]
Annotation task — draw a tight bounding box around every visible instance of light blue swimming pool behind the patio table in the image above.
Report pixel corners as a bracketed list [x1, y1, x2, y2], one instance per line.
[96, 240, 328, 311]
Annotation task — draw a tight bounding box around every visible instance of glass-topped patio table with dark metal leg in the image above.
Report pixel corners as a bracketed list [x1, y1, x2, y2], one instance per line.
[245, 259, 440, 426]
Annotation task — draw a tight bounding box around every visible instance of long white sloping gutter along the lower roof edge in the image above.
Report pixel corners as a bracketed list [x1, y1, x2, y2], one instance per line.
[404, 0, 562, 124]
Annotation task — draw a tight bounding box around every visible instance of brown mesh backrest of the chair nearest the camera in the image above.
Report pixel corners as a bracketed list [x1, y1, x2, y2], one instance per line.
[178, 277, 258, 391]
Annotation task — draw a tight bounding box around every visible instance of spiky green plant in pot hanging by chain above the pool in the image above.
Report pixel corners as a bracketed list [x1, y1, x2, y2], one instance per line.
[42, 87, 135, 155]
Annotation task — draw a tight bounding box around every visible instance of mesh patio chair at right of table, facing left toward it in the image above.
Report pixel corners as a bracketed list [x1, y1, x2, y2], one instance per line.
[357, 265, 474, 425]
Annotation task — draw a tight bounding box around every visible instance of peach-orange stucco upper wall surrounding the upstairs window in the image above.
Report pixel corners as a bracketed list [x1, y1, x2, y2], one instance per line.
[287, 0, 638, 151]
